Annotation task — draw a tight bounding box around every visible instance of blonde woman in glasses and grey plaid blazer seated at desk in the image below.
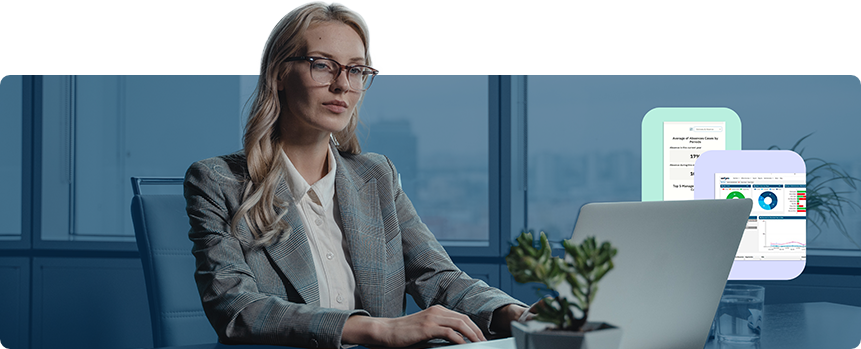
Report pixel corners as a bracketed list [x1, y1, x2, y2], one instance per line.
[185, 2, 526, 347]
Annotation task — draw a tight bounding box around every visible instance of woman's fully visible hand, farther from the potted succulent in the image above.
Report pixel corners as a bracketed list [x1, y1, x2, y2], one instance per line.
[341, 305, 487, 347]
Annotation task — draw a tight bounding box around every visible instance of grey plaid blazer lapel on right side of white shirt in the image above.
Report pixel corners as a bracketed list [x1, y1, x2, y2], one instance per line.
[335, 151, 386, 316]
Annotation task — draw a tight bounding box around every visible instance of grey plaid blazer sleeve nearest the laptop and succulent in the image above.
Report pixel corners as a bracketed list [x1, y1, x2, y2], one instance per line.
[386, 158, 528, 334]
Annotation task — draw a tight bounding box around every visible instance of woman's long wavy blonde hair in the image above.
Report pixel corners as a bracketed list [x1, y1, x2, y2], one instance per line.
[231, 1, 372, 247]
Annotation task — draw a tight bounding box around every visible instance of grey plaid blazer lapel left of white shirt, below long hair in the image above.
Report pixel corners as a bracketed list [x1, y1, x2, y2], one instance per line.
[266, 178, 320, 306]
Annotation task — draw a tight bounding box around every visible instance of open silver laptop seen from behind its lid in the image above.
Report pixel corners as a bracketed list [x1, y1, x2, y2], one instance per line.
[561, 199, 752, 349]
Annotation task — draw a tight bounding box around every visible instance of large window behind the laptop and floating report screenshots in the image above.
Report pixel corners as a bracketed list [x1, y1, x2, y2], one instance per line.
[527, 75, 861, 254]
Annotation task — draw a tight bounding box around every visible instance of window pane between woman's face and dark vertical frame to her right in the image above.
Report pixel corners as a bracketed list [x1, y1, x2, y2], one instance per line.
[357, 75, 489, 246]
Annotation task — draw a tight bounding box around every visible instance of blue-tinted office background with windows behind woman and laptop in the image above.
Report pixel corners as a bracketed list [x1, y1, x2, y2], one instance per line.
[0, 74, 861, 349]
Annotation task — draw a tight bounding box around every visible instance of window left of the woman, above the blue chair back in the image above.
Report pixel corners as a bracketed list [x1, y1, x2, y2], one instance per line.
[41, 75, 241, 241]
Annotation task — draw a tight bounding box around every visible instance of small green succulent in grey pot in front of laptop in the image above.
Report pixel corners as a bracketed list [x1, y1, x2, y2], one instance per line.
[505, 228, 622, 349]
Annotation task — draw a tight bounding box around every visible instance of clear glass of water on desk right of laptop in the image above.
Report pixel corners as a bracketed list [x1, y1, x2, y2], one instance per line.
[715, 284, 765, 343]
